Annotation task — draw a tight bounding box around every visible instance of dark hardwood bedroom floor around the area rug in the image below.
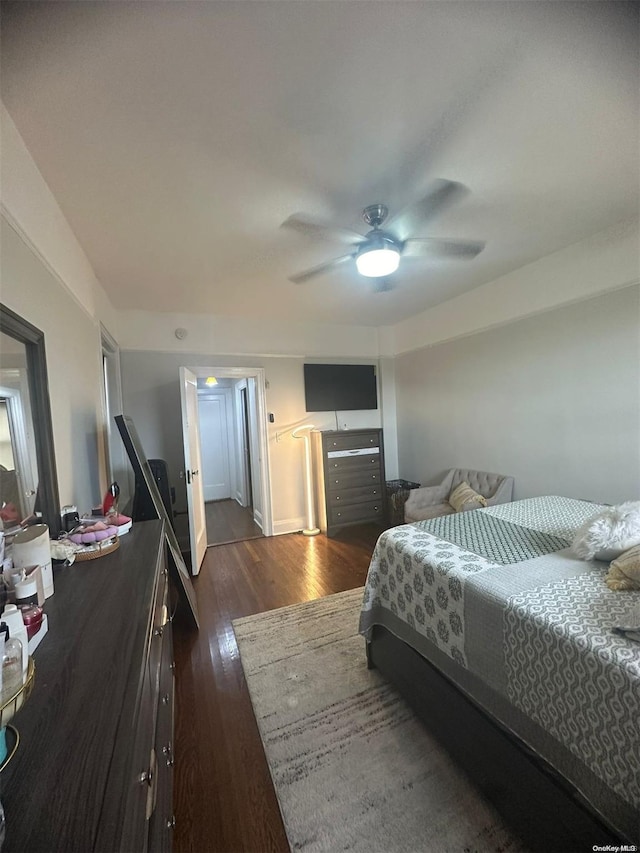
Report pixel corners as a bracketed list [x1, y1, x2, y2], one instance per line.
[173, 525, 381, 853]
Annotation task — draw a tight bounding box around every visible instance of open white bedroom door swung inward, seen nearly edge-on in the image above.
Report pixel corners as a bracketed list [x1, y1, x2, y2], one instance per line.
[180, 367, 207, 575]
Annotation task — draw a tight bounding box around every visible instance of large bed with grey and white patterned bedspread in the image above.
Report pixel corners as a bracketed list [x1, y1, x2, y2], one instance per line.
[360, 496, 640, 851]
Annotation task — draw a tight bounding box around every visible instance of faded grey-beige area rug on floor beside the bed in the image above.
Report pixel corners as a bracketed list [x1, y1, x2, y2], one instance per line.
[233, 589, 522, 853]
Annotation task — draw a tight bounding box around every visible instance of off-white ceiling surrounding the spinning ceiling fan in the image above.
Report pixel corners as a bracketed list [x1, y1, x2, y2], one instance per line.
[1, 0, 640, 326]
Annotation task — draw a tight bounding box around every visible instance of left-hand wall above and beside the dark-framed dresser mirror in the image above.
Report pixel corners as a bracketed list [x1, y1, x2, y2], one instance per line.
[0, 103, 122, 509]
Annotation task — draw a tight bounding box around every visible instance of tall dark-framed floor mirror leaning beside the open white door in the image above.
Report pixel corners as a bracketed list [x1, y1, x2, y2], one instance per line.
[115, 415, 199, 628]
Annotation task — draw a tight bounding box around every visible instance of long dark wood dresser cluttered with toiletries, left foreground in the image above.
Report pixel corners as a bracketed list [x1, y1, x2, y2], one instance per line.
[0, 521, 174, 853]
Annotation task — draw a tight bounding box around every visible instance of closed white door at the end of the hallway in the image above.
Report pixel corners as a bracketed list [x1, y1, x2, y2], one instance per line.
[199, 394, 231, 501]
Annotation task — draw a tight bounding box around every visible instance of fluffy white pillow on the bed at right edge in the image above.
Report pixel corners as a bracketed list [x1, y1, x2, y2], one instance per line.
[571, 501, 640, 560]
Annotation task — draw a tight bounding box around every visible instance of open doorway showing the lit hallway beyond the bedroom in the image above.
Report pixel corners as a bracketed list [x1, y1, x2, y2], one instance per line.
[180, 367, 272, 546]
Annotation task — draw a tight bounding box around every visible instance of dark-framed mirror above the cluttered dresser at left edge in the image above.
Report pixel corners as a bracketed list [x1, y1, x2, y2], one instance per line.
[0, 305, 60, 538]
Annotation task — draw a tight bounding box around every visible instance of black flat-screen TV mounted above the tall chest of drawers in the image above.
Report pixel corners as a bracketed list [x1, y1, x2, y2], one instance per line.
[304, 364, 378, 412]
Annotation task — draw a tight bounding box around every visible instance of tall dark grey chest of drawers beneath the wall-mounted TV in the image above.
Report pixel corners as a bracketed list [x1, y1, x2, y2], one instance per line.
[311, 429, 385, 537]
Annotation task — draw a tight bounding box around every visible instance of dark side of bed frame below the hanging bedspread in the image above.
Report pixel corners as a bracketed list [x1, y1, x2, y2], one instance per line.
[366, 625, 638, 853]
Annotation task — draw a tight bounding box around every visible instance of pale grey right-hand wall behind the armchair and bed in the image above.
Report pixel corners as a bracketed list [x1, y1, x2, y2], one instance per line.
[396, 285, 640, 503]
